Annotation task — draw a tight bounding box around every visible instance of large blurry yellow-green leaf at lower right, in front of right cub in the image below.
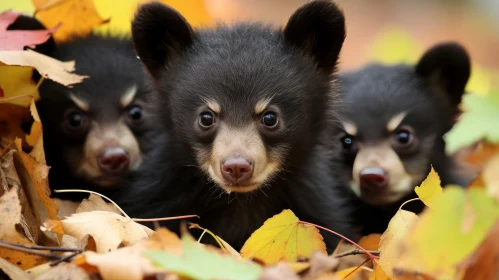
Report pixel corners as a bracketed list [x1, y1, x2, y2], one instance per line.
[396, 185, 499, 279]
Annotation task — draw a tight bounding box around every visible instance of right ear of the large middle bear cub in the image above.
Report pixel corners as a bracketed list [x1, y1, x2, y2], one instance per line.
[284, 0, 346, 73]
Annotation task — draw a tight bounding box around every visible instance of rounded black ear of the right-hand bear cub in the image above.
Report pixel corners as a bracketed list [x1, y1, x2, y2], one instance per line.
[416, 42, 471, 106]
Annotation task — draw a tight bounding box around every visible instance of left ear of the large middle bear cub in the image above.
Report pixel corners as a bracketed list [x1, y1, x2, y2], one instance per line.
[132, 2, 194, 78]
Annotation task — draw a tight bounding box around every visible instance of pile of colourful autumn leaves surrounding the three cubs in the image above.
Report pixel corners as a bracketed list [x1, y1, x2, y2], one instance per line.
[0, 0, 499, 280]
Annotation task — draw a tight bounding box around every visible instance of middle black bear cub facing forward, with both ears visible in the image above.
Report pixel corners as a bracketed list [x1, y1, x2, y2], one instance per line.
[125, 1, 356, 250]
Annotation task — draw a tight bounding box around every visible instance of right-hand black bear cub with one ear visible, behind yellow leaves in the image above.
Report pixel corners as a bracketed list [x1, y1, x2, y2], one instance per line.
[340, 43, 471, 234]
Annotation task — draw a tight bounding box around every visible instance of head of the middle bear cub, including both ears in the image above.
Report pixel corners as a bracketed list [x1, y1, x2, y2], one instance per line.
[132, 1, 345, 193]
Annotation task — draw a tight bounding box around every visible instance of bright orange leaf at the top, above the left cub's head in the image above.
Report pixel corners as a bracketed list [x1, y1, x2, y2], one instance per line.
[33, 0, 109, 41]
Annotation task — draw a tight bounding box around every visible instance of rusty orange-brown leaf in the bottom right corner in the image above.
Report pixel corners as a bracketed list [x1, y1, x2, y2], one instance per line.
[461, 222, 499, 280]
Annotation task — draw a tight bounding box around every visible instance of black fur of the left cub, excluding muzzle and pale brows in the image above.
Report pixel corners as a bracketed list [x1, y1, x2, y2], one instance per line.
[37, 32, 155, 200]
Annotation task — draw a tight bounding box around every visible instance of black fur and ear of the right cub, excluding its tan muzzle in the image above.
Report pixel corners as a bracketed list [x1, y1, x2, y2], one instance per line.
[340, 43, 471, 234]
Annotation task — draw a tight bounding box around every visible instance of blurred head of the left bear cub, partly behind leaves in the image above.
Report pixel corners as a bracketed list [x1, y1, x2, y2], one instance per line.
[38, 35, 156, 188]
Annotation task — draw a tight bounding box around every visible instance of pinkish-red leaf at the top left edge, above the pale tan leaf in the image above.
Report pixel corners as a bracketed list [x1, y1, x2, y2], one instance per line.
[0, 10, 59, 51]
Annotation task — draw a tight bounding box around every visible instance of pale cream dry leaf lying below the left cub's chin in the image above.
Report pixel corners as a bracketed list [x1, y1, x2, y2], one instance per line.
[56, 211, 153, 253]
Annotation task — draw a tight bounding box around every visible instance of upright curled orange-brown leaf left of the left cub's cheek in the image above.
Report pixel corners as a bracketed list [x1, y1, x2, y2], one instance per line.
[15, 139, 58, 225]
